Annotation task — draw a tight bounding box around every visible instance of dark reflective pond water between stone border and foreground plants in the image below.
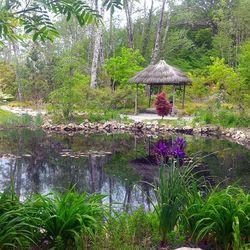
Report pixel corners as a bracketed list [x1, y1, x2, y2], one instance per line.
[0, 130, 250, 208]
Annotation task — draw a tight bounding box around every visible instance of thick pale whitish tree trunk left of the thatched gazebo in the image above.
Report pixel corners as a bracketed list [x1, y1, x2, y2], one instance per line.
[90, 1, 104, 88]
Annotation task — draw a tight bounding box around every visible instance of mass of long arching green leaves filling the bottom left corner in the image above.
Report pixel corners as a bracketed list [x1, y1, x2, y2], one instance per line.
[0, 188, 105, 250]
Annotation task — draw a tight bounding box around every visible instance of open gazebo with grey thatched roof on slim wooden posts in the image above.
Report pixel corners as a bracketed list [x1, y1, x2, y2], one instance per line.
[129, 60, 191, 114]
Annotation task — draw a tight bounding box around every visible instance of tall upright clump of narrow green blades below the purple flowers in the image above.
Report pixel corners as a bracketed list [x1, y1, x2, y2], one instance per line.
[151, 160, 202, 242]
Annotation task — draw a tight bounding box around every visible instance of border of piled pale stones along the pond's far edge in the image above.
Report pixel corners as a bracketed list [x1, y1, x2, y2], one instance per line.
[42, 120, 250, 148]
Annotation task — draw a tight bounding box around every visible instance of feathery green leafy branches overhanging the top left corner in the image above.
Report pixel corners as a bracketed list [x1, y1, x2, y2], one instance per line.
[0, 0, 121, 43]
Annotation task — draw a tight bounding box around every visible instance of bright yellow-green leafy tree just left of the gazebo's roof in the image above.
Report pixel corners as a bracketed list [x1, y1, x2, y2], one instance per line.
[104, 48, 144, 86]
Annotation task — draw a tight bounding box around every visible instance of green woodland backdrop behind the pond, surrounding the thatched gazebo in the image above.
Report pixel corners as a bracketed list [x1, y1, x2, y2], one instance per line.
[0, 0, 250, 126]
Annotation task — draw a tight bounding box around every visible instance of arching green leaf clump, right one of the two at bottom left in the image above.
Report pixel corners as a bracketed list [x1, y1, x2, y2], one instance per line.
[27, 191, 104, 249]
